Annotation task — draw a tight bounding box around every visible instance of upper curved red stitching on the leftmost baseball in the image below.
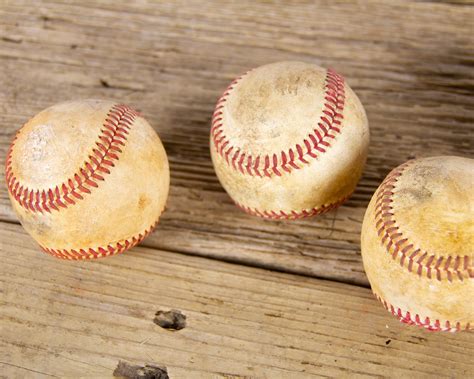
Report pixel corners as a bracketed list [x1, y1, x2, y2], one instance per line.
[5, 104, 139, 213]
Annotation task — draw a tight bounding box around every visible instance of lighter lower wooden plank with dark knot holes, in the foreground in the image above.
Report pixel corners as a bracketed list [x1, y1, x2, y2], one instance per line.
[0, 223, 474, 379]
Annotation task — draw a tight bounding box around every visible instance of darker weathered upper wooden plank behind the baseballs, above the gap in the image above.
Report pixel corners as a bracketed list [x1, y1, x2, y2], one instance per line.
[0, 0, 474, 286]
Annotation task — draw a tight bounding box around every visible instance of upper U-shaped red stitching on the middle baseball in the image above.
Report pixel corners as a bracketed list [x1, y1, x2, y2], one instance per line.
[211, 69, 345, 177]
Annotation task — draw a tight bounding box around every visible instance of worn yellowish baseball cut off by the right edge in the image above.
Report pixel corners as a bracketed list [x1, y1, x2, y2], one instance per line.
[362, 156, 474, 331]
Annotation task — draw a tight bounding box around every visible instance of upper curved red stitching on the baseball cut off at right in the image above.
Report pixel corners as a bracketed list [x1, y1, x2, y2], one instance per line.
[374, 160, 474, 282]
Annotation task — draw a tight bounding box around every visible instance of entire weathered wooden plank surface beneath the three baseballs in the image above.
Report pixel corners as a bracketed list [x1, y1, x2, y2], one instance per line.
[0, 0, 474, 377]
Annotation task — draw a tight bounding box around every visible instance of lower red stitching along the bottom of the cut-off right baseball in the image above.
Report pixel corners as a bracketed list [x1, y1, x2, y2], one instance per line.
[374, 292, 471, 332]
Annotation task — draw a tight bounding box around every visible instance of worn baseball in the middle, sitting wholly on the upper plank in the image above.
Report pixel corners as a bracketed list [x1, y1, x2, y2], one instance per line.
[210, 62, 369, 219]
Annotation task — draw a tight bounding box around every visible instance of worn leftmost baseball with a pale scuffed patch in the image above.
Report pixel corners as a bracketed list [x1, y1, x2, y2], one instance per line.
[5, 100, 170, 259]
